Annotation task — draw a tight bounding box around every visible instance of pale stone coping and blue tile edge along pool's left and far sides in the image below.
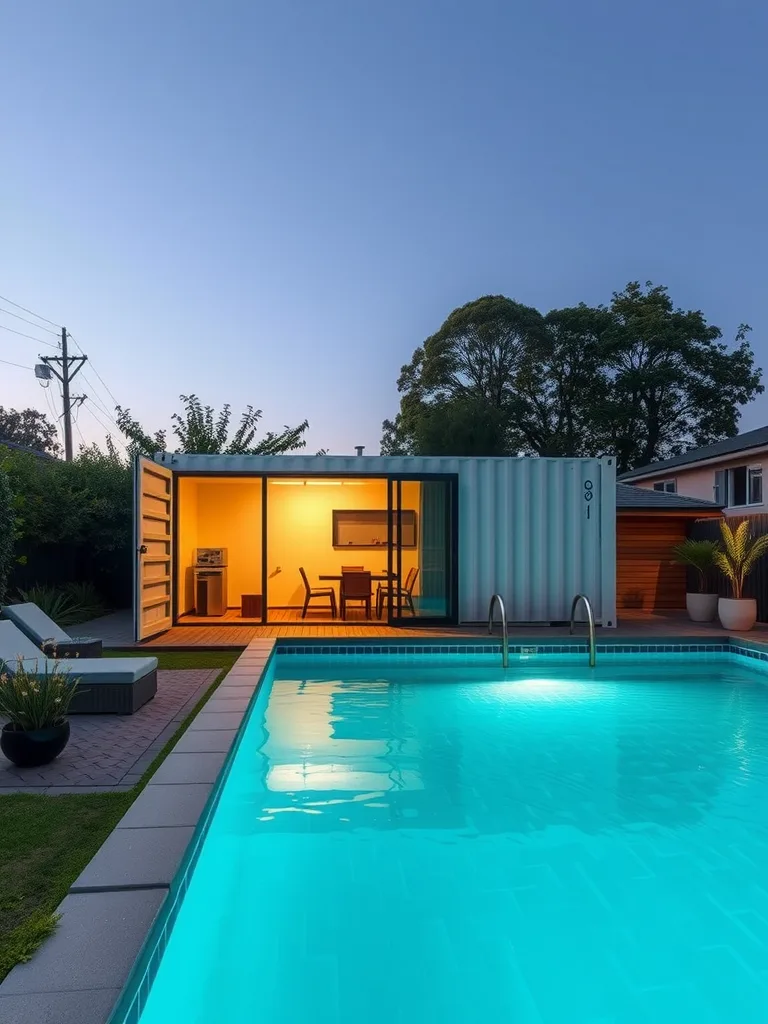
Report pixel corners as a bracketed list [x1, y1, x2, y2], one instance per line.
[0, 635, 768, 1024]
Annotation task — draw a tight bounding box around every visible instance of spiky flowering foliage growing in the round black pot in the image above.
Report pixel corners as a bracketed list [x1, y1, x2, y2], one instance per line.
[0, 659, 78, 731]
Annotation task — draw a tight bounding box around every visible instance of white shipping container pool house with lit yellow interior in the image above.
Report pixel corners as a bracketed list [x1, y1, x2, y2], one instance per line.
[134, 453, 615, 640]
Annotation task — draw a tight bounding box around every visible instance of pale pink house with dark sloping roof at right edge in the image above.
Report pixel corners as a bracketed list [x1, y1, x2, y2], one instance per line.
[618, 427, 768, 515]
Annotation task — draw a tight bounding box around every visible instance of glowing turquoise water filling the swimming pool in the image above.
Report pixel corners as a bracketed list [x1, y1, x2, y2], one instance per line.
[135, 654, 768, 1024]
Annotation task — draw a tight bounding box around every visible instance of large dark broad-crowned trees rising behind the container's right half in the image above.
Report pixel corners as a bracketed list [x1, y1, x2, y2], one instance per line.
[382, 283, 763, 471]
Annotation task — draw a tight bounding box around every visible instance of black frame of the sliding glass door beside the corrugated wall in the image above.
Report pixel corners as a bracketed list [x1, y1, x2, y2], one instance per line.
[386, 473, 459, 627]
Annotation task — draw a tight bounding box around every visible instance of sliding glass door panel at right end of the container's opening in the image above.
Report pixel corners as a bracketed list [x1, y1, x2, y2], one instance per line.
[391, 475, 458, 626]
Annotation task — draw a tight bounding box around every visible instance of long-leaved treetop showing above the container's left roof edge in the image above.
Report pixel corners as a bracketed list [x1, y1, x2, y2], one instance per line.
[117, 394, 319, 457]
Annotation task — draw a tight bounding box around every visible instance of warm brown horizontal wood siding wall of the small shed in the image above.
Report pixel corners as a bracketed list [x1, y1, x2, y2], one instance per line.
[616, 515, 688, 616]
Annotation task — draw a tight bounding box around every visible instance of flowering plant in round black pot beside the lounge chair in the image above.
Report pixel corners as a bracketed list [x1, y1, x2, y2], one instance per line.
[0, 657, 78, 768]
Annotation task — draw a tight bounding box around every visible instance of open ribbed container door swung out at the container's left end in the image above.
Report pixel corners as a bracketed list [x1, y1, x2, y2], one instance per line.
[133, 457, 173, 641]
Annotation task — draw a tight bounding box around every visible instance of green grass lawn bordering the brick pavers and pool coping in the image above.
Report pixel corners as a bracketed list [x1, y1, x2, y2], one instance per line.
[0, 650, 240, 980]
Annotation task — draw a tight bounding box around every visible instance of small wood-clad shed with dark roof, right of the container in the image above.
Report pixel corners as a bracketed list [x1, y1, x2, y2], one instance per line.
[616, 483, 722, 622]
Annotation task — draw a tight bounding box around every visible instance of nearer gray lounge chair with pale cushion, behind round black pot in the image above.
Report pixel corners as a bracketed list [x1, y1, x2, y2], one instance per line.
[0, 620, 158, 715]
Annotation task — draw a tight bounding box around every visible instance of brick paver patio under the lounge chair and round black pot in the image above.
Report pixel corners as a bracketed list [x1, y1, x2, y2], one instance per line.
[0, 669, 221, 795]
